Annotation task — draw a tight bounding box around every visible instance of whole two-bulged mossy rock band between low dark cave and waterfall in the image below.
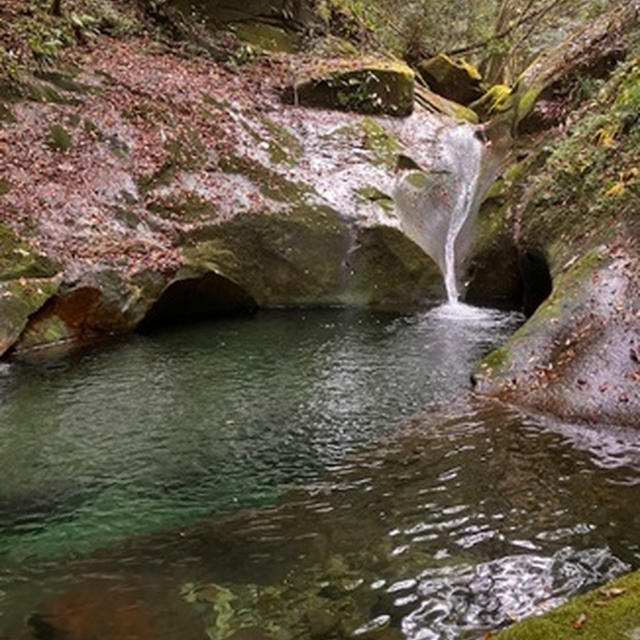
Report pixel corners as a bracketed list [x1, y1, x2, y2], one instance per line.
[183, 211, 443, 309]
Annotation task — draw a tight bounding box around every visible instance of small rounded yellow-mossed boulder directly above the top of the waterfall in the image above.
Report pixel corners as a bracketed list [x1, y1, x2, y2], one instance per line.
[417, 53, 483, 106]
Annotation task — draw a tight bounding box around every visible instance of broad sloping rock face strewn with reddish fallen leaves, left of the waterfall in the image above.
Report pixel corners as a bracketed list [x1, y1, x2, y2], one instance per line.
[0, 41, 455, 352]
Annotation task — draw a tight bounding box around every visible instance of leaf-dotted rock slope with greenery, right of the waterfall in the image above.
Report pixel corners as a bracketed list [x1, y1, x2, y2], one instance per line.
[475, 50, 640, 426]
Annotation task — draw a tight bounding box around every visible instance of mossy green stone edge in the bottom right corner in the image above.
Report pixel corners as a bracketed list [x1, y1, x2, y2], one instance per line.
[496, 570, 640, 640]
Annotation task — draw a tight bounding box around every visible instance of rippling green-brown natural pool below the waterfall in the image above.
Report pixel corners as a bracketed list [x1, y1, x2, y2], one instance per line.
[0, 309, 640, 640]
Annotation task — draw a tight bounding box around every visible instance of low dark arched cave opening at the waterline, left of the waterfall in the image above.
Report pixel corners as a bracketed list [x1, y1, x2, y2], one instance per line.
[138, 272, 257, 331]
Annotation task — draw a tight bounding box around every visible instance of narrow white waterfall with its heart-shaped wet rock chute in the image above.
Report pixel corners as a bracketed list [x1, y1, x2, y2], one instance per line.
[394, 124, 501, 305]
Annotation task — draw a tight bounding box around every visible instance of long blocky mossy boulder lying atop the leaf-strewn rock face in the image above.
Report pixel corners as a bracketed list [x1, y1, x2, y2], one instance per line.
[284, 62, 415, 116]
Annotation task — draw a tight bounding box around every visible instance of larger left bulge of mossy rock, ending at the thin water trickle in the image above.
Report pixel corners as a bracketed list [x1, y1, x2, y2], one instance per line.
[183, 204, 349, 307]
